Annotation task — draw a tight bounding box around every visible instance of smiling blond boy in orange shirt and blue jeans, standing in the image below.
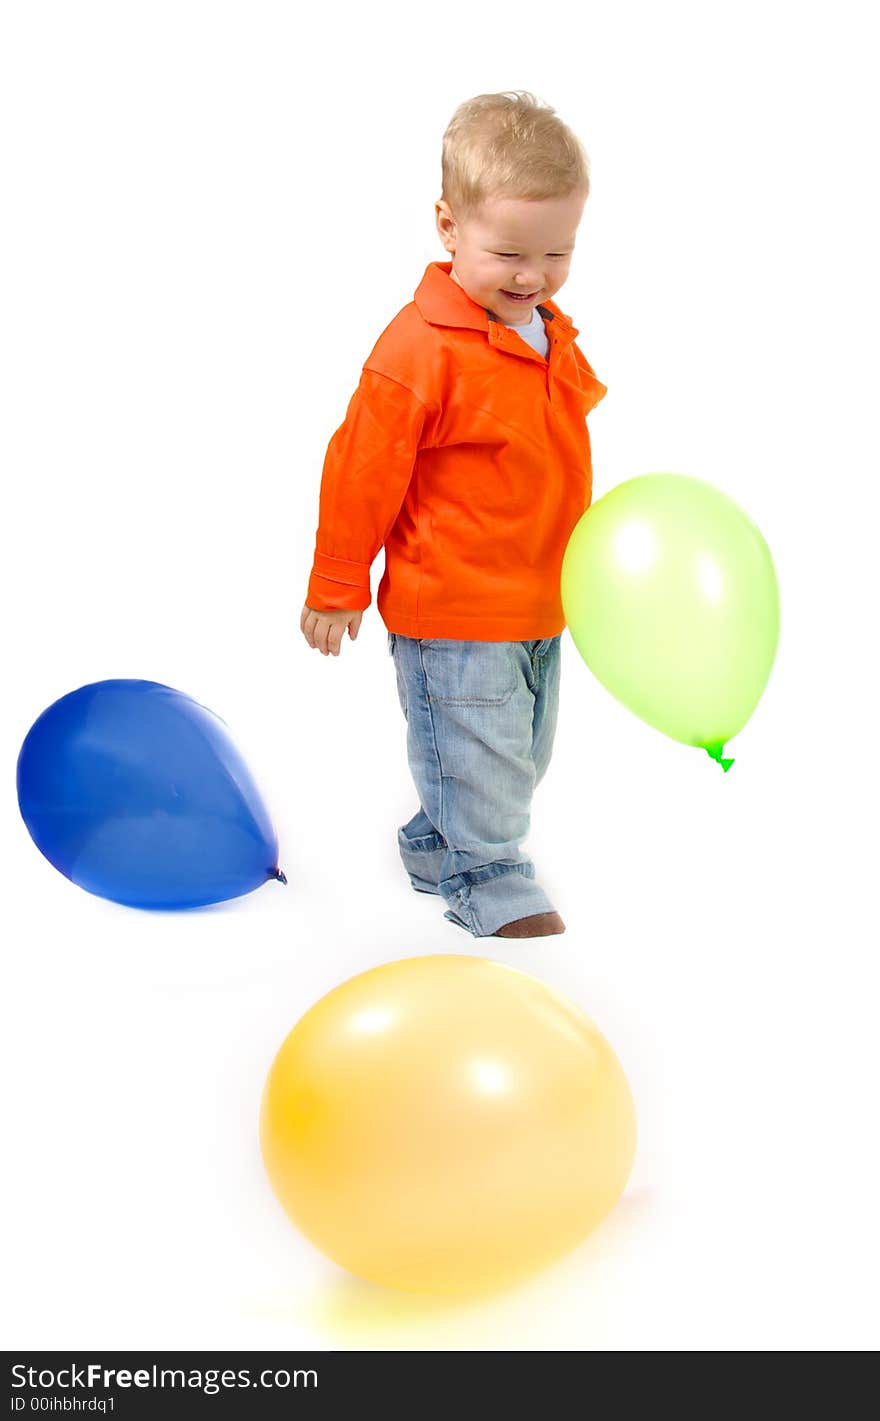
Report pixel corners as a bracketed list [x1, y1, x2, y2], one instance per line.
[300, 92, 606, 938]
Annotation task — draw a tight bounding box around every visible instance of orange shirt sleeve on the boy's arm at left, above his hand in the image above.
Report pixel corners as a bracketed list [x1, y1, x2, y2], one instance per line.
[306, 368, 426, 611]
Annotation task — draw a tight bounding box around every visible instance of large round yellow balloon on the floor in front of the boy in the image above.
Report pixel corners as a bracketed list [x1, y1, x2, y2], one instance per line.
[260, 956, 635, 1293]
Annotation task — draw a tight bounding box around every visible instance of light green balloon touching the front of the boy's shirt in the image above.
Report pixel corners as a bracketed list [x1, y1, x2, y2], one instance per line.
[562, 473, 779, 770]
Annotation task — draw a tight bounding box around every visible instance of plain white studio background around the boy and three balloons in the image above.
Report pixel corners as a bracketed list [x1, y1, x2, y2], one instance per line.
[0, 0, 880, 1350]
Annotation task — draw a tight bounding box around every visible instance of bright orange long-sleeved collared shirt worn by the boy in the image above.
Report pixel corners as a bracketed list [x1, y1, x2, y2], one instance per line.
[306, 261, 606, 641]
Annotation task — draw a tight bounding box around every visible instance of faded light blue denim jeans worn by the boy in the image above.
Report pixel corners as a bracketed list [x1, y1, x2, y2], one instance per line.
[388, 632, 562, 938]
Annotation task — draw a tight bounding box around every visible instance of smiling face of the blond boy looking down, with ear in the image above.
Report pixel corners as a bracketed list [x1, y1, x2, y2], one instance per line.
[435, 192, 587, 325]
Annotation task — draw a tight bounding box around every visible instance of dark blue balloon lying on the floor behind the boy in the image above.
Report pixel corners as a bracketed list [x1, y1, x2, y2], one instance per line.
[18, 681, 286, 908]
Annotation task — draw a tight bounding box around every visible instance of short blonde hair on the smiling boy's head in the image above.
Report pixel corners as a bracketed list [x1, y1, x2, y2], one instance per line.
[441, 90, 590, 220]
